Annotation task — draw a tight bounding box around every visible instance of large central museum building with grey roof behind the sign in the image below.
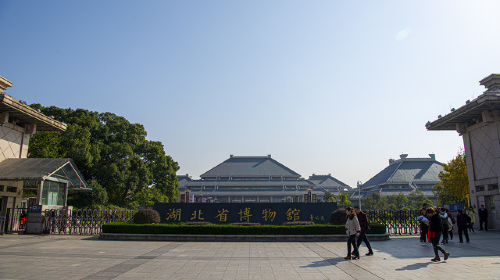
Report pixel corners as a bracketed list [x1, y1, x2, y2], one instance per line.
[182, 155, 325, 202]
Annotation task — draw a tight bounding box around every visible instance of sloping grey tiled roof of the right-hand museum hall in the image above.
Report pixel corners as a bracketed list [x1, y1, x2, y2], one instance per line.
[361, 158, 443, 189]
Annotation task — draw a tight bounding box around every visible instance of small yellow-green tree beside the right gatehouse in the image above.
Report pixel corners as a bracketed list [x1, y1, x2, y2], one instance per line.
[433, 151, 470, 206]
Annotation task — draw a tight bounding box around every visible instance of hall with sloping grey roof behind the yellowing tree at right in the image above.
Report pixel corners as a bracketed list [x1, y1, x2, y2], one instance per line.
[351, 154, 443, 205]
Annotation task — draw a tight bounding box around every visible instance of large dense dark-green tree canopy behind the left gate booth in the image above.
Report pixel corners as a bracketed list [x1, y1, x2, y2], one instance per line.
[28, 104, 179, 208]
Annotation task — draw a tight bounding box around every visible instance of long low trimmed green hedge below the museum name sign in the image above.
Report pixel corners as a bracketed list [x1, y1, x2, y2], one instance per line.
[102, 222, 386, 235]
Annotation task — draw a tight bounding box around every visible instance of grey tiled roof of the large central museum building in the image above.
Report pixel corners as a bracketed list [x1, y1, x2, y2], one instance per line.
[200, 156, 300, 178]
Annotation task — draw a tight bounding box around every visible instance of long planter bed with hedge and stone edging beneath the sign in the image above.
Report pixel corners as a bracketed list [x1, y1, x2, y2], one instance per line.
[100, 222, 389, 241]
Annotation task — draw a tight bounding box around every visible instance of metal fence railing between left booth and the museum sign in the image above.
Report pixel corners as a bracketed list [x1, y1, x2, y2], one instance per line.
[43, 209, 135, 234]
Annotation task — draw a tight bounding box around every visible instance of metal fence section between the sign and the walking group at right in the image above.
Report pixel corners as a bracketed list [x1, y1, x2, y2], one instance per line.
[365, 210, 421, 235]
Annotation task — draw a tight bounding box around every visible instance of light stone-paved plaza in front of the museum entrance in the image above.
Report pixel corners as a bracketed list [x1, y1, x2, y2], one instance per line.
[0, 231, 500, 280]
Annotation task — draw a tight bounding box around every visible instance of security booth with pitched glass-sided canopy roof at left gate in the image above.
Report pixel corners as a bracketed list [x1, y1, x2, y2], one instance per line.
[0, 158, 92, 234]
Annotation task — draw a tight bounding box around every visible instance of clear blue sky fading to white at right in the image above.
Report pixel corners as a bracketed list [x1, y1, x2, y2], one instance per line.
[0, 0, 500, 186]
